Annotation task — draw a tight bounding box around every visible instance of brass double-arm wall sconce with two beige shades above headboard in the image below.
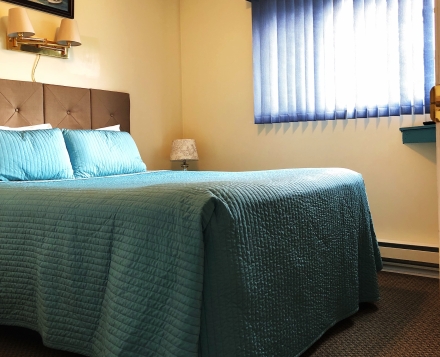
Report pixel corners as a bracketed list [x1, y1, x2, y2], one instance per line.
[6, 7, 81, 58]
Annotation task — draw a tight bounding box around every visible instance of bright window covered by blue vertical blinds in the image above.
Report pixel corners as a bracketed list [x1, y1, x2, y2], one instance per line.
[249, 0, 435, 124]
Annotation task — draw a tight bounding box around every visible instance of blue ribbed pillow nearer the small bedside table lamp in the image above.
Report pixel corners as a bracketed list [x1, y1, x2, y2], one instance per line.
[63, 129, 146, 178]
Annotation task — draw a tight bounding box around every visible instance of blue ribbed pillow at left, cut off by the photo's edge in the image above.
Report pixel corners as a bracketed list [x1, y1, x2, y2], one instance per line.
[0, 129, 74, 181]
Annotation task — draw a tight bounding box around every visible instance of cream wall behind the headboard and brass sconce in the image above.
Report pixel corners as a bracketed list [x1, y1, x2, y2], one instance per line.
[0, 0, 182, 169]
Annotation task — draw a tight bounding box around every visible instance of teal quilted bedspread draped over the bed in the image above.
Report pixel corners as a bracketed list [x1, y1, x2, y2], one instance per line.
[0, 169, 381, 357]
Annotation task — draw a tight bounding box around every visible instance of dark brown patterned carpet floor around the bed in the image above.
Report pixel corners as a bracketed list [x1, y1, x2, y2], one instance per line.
[0, 272, 440, 357]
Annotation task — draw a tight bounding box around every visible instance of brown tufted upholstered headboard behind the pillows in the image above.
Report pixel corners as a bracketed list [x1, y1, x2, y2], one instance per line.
[0, 79, 130, 132]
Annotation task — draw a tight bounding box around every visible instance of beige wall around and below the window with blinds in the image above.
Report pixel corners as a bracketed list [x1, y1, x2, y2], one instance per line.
[180, 0, 438, 246]
